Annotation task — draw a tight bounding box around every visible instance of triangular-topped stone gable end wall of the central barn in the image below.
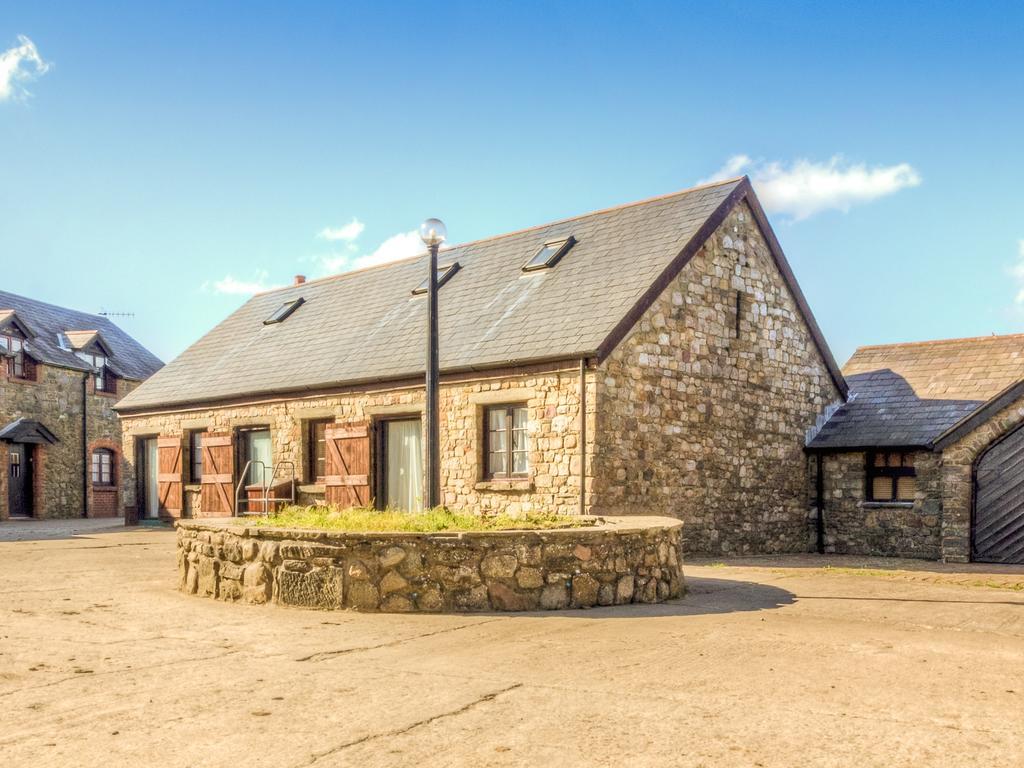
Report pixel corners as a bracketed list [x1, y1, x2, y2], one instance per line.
[592, 203, 840, 554]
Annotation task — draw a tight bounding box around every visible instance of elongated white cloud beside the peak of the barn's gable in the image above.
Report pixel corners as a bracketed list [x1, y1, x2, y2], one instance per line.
[701, 155, 921, 220]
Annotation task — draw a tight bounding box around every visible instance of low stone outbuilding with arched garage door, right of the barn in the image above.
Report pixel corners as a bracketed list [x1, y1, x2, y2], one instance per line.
[809, 335, 1024, 563]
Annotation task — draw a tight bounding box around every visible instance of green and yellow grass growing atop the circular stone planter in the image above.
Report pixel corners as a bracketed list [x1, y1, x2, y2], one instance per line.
[240, 506, 593, 534]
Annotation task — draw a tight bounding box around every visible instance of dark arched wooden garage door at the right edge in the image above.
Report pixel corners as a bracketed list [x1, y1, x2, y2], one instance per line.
[972, 428, 1024, 563]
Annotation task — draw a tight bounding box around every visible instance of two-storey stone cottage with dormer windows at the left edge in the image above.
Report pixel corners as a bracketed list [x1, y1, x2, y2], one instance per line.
[0, 291, 162, 519]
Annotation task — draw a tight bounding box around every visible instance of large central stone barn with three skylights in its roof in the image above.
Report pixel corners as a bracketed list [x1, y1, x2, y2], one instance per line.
[118, 178, 846, 553]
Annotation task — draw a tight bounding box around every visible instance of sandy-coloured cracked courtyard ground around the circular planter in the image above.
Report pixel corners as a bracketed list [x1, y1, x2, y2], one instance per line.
[0, 521, 1024, 768]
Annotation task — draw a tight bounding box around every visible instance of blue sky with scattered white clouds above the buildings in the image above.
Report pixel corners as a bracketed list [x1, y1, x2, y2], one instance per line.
[0, 0, 1024, 361]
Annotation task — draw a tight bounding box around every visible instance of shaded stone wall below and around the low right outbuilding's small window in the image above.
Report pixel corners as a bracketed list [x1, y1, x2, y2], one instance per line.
[808, 451, 943, 560]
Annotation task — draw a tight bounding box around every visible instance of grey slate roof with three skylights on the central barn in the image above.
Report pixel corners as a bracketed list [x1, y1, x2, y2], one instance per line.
[118, 178, 842, 411]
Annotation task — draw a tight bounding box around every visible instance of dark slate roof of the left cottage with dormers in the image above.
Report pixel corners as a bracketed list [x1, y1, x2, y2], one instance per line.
[0, 291, 163, 381]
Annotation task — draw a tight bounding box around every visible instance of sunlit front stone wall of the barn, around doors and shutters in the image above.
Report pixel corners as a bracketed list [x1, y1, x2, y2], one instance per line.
[123, 370, 593, 516]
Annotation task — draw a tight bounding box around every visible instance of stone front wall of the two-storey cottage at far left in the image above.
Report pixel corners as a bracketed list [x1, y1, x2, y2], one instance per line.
[0, 364, 137, 519]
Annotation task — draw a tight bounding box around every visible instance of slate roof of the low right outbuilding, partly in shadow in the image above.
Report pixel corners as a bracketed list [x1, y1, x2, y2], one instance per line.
[809, 334, 1024, 449]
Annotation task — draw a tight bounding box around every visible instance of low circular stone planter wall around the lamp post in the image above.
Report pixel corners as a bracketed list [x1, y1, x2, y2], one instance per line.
[176, 517, 683, 611]
